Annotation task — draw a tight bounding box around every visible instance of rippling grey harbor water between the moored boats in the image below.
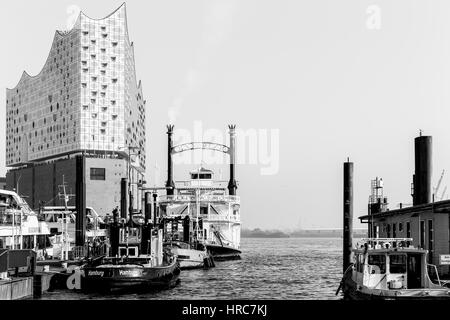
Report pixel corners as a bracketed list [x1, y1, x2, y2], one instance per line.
[41, 238, 342, 300]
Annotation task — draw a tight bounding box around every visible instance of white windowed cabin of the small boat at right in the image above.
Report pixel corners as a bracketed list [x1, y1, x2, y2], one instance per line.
[352, 238, 439, 290]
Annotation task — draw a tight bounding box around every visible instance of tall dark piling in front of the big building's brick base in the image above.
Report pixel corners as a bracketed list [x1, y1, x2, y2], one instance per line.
[75, 156, 86, 247]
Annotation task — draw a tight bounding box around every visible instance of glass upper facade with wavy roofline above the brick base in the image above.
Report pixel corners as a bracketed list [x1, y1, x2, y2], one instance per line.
[6, 4, 146, 169]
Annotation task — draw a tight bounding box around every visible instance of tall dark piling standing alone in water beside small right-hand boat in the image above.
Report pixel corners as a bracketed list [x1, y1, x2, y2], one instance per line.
[343, 160, 353, 273]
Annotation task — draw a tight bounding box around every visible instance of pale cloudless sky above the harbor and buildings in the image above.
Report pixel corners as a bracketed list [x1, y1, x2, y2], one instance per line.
[0, 0, 450, 229]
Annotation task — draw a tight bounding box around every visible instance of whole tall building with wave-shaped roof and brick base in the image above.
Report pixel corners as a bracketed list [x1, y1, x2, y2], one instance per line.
[6, 4, 146, 215]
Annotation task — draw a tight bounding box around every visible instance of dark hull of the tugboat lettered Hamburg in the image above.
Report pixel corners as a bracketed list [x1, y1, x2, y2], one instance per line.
[82, 261, 180, 291]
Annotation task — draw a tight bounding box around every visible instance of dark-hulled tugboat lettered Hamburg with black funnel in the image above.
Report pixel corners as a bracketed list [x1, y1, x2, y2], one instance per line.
[81, 210, 180, 292]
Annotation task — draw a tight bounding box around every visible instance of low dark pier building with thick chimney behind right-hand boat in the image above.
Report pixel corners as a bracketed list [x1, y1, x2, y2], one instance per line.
[359, 133, 450, 279]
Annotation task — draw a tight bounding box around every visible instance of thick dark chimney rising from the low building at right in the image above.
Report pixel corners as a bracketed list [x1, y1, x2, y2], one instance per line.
[413, 132, 432, 206]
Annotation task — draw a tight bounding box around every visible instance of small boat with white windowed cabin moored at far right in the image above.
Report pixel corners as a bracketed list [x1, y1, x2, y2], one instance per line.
[336, 238, 450, 300]
